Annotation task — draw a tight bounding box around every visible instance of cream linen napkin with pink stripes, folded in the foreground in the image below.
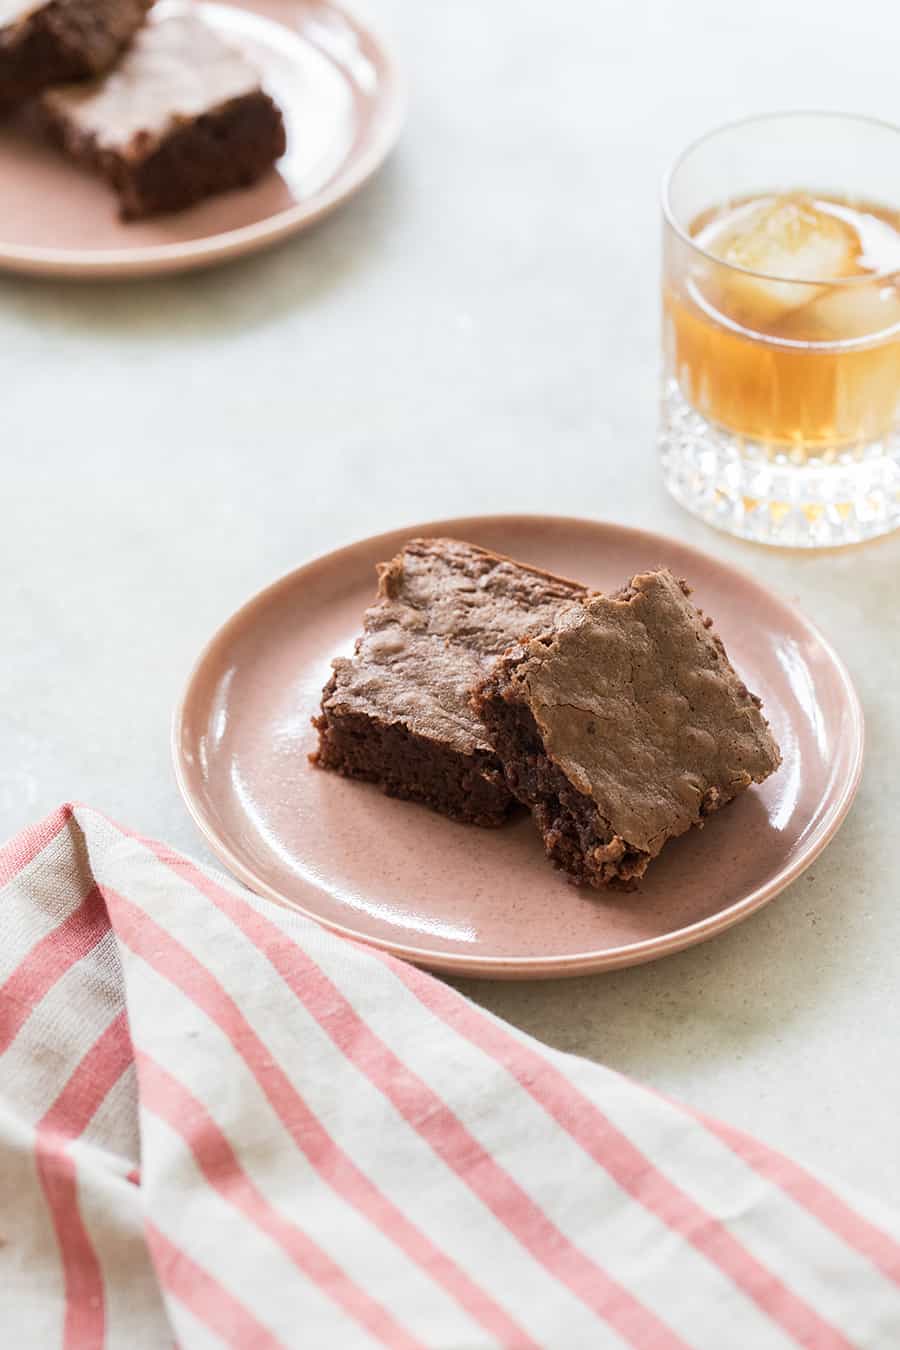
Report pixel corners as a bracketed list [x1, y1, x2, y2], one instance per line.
[0, 806, 900, 1350]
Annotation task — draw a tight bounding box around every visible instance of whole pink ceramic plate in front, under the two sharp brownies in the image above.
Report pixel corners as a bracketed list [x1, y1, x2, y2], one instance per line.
[174, 516, 862, 977]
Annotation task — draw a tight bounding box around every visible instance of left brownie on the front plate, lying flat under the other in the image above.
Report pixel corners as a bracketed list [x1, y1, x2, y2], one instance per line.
[310, 539, 588, 825]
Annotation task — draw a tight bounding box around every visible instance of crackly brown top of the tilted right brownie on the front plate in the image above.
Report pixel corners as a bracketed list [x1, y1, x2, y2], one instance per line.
[493, 570, 780, 853]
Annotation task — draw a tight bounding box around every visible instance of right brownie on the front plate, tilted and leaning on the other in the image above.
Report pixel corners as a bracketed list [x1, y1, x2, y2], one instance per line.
[474, 570, 781, 886]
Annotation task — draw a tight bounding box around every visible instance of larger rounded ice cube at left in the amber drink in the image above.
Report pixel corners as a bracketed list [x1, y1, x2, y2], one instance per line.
[698, 196, 860, 328]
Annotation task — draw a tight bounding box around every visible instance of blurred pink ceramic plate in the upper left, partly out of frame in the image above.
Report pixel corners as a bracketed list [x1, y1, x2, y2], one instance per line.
[0, 0, 403, 277]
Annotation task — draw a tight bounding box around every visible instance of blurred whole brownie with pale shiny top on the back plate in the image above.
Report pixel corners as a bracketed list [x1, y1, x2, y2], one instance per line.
[42, 12, 286, 220]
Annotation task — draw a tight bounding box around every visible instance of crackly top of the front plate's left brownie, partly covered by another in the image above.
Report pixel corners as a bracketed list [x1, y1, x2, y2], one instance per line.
[324, 539, 587, 755]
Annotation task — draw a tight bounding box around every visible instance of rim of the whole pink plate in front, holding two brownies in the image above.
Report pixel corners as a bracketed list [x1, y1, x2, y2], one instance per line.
[171, 513, 865, 980]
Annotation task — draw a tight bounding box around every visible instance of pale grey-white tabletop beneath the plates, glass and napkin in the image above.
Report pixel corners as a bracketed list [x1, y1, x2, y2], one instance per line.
[0, 0, 900, 1197]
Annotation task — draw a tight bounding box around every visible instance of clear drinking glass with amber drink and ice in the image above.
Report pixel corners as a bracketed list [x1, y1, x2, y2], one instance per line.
[660, 112, 900, 547]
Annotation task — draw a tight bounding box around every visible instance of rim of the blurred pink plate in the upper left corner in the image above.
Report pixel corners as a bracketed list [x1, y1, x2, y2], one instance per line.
[0, 0, 409, 281]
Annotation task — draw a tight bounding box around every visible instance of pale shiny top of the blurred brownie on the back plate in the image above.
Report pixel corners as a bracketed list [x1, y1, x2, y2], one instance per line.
[43, 14, 260, 155]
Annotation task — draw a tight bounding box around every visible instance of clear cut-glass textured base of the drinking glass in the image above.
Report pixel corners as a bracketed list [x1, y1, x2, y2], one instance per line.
[660, 379, 900, 548]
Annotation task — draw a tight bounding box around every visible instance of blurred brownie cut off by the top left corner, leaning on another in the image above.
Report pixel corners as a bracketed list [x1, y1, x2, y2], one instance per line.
[0, 0, 152, 111]
